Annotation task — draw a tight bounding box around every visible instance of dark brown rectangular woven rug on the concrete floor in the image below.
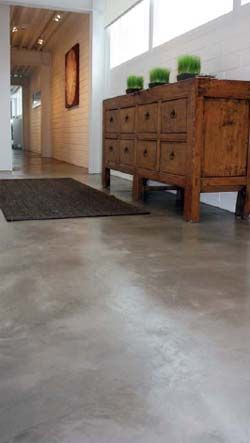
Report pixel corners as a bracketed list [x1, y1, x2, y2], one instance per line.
[0, 178, 149, 221]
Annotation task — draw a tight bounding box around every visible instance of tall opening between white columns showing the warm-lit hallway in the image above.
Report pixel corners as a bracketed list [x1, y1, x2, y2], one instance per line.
[10, 6, 91, 169]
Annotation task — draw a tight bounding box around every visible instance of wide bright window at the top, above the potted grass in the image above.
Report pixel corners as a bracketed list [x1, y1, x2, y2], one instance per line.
[153, 0, 233, 46]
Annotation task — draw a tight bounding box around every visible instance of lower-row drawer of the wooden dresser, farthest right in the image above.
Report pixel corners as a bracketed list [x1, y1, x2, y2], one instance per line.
[160, 143, 187, 175]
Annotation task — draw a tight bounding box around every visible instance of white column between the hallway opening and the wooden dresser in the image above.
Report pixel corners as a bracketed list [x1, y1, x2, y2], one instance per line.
[89, 1, 105, 174]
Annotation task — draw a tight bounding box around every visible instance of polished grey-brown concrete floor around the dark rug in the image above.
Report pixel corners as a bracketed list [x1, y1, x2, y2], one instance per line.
[0, 154, 250, 443]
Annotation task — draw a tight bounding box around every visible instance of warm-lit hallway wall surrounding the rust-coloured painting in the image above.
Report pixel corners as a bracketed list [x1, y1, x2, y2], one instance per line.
[50, 14, 90, 168]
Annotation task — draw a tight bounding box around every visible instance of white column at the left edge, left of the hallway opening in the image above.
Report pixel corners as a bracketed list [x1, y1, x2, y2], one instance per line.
[0, 5, 12, 171]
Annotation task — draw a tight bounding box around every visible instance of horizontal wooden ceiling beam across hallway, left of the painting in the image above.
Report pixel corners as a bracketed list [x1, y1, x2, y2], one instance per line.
[11, 48, 51, 66]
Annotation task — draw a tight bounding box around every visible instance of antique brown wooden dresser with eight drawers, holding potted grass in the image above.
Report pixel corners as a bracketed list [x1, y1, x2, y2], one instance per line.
[103, 78, 250, 222]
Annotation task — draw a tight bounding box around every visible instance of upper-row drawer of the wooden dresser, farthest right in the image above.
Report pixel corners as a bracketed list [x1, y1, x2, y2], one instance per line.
[161, 99, 187, 133]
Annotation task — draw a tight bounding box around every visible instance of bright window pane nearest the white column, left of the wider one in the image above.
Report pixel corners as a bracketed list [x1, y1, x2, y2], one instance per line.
[109, 0, 149, 68]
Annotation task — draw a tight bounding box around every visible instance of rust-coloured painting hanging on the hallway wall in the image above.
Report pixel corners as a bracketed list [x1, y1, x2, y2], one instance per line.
[65, 44, 80, 108]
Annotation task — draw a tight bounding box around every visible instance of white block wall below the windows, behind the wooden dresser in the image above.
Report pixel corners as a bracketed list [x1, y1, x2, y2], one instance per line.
[105, 0, 250, 211]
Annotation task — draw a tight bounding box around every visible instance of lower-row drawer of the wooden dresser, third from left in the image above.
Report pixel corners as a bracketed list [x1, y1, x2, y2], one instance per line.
[136, 140, 157, 169]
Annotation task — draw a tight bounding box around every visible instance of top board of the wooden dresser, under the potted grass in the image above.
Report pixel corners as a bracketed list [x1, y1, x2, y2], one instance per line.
[103, 77, 250, 108]
